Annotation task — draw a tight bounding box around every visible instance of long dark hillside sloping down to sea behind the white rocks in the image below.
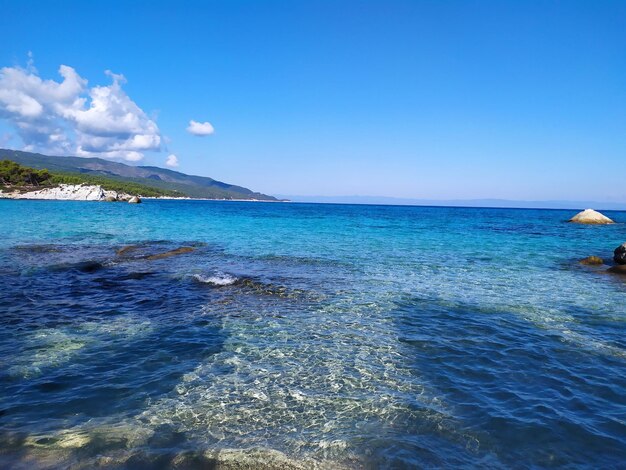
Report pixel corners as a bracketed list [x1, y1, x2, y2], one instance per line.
[0, 149, 278, 201]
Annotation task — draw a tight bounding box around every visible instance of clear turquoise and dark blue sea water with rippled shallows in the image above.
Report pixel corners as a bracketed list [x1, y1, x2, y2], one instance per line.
[0, 200, 626, 468]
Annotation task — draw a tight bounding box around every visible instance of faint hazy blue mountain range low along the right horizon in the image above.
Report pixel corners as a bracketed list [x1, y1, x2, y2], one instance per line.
[277, 195, 626, 211]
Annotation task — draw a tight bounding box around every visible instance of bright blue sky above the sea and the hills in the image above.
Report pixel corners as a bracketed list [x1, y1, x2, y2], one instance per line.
[0, 0, 626, 202]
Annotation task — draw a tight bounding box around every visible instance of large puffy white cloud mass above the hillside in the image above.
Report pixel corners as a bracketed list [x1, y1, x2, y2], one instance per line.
[0, 60, 161, 161]
